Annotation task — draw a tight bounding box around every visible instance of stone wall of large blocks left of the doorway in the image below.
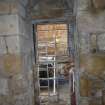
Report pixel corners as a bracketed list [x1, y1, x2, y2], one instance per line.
[0, 0, 33, 105]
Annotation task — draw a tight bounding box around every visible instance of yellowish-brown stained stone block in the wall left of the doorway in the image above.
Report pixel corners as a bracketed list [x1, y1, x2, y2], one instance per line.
[0, 54, 22, 77]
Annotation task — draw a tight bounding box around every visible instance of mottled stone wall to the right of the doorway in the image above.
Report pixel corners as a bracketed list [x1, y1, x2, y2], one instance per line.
[77, 0, 105, 105]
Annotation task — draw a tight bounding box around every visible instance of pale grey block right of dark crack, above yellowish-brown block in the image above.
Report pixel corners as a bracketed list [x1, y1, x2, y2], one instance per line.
[6, 36, 20, 54]
